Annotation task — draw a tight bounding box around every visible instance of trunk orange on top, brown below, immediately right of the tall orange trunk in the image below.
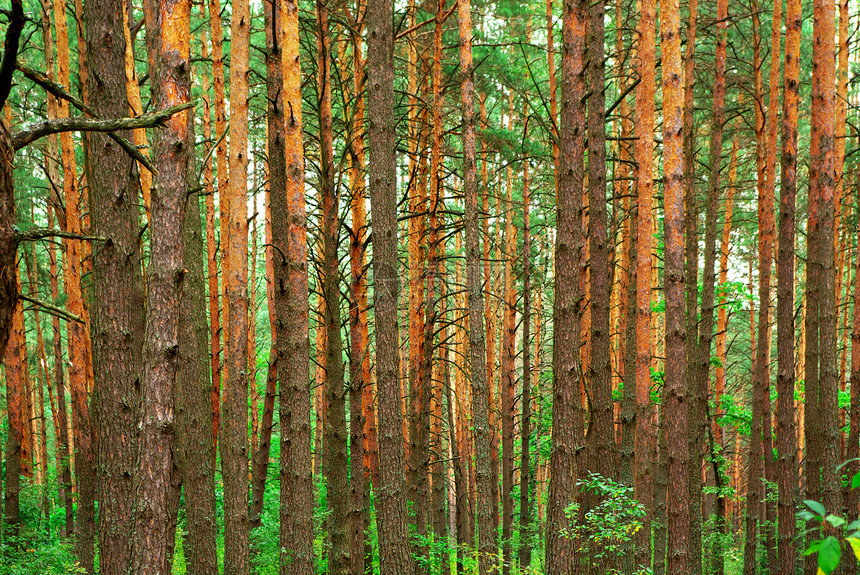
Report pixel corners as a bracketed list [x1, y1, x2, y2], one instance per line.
[660, 1, 692, 573]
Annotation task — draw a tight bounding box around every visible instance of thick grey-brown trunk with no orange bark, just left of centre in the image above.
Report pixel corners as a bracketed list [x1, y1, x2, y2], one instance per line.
[366, 0, 414, 575]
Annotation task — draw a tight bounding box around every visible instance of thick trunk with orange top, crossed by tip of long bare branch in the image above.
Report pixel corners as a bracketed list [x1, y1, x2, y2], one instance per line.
[130, 0, 193, 574]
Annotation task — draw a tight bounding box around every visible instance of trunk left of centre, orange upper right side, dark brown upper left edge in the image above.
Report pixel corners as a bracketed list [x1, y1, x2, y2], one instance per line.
[269, 0, 314, 575]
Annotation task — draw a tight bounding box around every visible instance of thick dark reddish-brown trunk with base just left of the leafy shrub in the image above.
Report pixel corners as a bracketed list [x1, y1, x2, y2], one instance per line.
[546, 0, 587, 575]
